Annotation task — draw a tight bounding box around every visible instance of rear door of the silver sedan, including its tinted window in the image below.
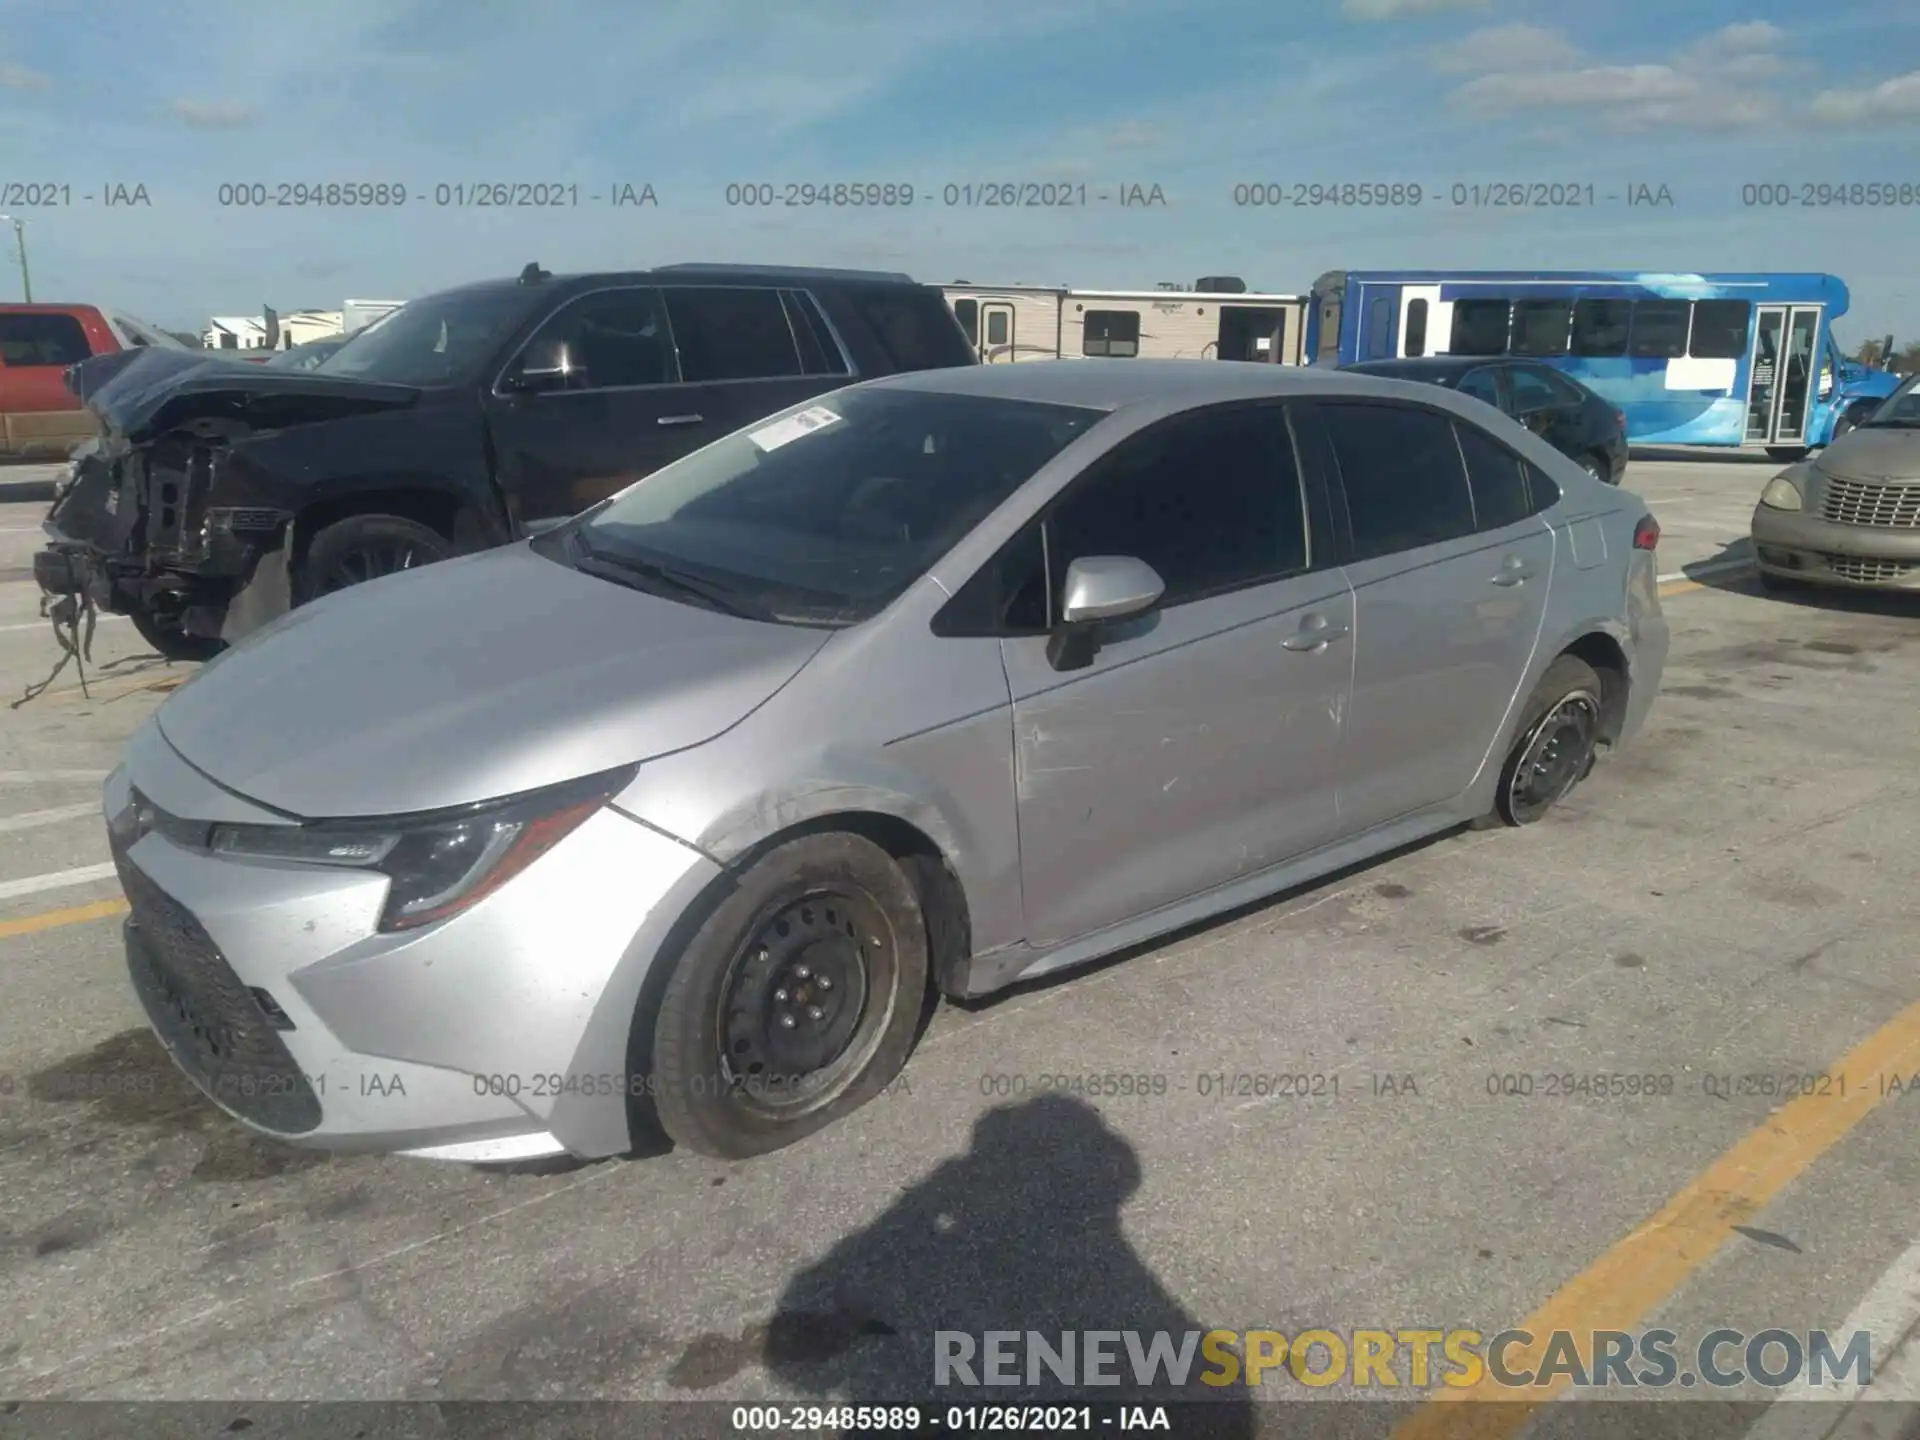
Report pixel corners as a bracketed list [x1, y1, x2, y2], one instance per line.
[1304, 399, 1553, 829]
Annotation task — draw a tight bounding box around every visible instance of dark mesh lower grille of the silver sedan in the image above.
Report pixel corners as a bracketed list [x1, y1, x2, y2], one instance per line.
[111, 837, 321, 1135]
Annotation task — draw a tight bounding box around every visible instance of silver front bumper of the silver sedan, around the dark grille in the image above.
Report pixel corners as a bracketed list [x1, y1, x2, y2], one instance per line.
[104, 722, 718, 1164]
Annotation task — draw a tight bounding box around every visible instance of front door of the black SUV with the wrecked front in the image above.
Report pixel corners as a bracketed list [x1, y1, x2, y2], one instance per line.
[488, 286, 724, 524]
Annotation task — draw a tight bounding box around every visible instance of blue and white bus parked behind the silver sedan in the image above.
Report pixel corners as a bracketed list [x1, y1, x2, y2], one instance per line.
[1306, 271, 1899, 459]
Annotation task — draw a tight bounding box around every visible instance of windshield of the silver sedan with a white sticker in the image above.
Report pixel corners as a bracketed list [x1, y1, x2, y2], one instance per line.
[563, 388, 1104, 626]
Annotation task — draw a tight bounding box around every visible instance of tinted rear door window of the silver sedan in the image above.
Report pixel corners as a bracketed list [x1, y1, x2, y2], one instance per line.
[1321, 403, 1475, 561]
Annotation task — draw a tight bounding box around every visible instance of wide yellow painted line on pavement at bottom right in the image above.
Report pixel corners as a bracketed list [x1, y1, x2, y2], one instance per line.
[1394, 1002, 1920, 1440]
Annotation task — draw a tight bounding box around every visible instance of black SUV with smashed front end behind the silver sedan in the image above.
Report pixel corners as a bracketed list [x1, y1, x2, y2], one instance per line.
[35, 265, 977, 660]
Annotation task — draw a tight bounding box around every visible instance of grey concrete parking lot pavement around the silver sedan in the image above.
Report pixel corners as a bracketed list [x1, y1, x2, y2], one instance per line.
[0, 455, 1920, 1440]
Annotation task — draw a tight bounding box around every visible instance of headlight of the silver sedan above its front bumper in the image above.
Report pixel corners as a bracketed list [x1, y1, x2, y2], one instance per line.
[207, 766, 637, 931]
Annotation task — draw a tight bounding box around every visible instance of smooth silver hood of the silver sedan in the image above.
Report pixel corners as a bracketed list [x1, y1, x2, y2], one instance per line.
[156, 543, 831, 818]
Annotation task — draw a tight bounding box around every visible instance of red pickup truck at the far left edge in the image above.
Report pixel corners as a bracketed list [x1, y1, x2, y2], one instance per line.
[0, 303, 184, 461]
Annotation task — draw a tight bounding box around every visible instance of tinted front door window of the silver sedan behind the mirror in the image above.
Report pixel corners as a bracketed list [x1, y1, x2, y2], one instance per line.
[1046, 405, 1308, 614]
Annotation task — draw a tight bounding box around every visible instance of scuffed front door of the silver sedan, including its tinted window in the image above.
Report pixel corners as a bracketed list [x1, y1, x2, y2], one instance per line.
[1002, 403, 1354, 947]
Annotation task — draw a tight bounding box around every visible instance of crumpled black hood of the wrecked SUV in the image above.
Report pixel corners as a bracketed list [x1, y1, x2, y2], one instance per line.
[65, 348, 420, 444]
